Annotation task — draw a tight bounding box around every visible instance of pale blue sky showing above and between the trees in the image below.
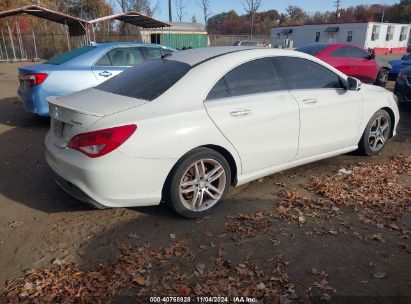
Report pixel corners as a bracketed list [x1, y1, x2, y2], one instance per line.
[152, 0, 399, 23]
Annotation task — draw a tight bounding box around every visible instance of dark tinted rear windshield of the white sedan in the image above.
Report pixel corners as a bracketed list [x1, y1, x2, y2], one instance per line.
[96, 59, 191, 101]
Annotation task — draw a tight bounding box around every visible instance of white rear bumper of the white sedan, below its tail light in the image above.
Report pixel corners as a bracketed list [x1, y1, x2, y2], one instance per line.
[46, 133, 177, 208]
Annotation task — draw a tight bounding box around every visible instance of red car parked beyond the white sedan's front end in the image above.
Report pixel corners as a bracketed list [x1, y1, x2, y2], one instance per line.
[297, 43, 390, 87]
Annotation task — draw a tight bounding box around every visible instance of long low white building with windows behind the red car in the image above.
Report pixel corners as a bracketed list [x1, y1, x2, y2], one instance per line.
[271, 22, 411, 54]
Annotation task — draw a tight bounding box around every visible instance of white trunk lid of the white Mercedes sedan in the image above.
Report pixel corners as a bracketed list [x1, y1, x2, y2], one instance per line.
[47, 89, 148, 149]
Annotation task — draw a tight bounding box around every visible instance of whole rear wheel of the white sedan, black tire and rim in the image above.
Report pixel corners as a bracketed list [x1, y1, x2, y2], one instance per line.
[166, 148, 231, 218]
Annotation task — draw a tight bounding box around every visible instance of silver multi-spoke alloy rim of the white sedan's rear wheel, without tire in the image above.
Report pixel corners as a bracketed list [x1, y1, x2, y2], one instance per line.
[179, 159, 227, 212]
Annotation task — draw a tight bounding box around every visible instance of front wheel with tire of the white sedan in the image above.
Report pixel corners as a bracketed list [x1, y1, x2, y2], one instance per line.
[358, 110, 391, 156]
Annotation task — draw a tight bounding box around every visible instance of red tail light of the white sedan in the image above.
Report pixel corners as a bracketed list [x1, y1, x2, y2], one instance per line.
[68, 125, 137, 158]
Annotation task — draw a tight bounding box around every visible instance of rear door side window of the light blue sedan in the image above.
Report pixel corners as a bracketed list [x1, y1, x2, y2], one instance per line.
[96, 47, 145, 66]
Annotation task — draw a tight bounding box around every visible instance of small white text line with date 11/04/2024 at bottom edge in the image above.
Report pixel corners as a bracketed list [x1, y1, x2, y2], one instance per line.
[150, 297, 257, 303]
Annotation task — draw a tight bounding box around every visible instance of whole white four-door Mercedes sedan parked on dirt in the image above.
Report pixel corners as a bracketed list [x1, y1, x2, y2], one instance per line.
[46, 47, 399, 218]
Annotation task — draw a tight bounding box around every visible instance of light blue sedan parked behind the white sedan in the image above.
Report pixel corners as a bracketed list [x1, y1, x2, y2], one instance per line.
[17, 43, 175, 116]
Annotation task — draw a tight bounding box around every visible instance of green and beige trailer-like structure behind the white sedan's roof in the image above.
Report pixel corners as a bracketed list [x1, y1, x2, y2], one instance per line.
[148, 22, 209, 50]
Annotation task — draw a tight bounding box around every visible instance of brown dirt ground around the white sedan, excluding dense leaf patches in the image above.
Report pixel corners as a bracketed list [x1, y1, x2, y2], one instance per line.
[0, 60, 411, 303]
